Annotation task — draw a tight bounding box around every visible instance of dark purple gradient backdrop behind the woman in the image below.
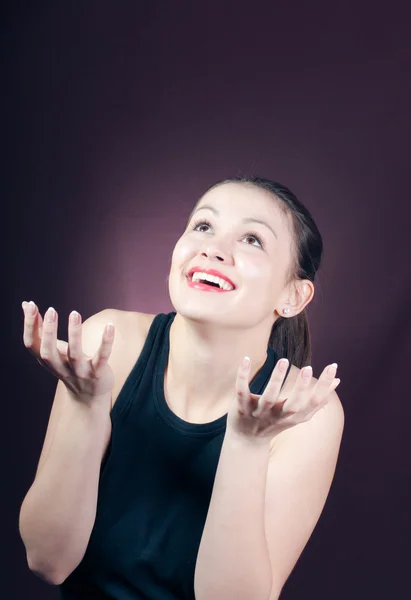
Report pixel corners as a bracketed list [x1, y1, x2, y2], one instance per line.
[1, 0, 411, 600]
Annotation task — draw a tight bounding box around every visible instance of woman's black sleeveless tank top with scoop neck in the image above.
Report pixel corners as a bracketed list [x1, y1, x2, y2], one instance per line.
[59, 312, 291, 600]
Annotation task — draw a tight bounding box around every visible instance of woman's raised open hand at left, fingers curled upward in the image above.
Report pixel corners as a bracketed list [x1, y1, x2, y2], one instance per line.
[22, 302, 114, 404]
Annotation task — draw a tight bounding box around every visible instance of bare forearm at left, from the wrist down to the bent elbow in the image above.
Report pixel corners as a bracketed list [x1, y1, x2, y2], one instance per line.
[19, 392, 111, 585]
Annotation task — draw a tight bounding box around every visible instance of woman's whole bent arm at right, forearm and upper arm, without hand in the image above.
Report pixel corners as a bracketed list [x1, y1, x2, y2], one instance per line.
[195, 390, 344, 600]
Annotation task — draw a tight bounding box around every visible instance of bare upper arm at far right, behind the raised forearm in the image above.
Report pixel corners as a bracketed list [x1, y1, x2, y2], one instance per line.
[265, 391, 344, 600]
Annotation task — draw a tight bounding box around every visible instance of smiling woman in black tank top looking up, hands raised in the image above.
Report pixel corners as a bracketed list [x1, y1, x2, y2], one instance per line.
[19, 177, 344, 600]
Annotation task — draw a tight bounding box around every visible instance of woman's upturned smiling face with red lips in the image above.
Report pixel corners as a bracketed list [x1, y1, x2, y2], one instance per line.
[169, 183, 292, 328]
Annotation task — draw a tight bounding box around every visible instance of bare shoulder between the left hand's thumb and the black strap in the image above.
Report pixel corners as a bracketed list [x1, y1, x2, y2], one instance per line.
[100, 308, 156, 407]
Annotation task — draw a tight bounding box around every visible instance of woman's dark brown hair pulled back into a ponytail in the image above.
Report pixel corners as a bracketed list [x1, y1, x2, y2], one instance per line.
[193, 176, 323, 368]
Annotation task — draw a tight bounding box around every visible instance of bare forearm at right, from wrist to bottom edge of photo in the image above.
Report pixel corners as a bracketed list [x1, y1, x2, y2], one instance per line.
[194, 431, 272, 600]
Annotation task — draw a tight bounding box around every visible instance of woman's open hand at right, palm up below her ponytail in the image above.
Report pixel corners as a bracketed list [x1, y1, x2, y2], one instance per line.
[227, 358, 340, 440]
